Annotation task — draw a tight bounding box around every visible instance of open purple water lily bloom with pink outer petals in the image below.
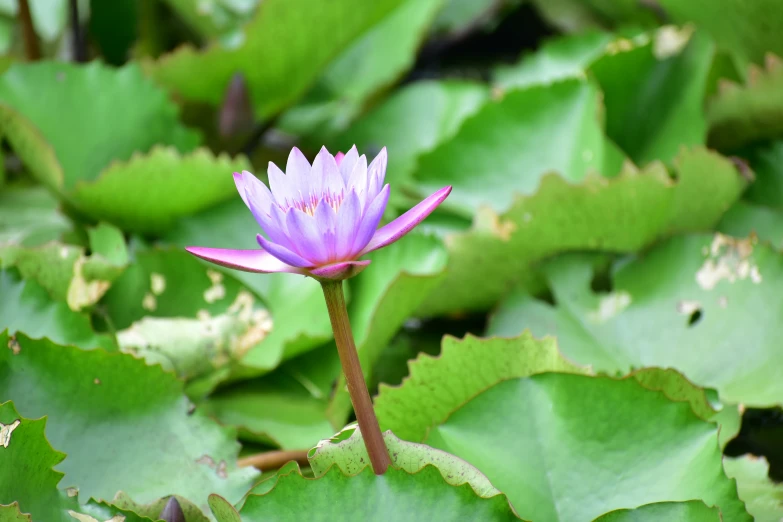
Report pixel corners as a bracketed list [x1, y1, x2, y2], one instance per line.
[187, 146, 451, 280]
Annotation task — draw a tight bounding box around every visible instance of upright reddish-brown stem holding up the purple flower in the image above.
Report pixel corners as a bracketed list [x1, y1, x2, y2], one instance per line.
[321, 281, 391, 475]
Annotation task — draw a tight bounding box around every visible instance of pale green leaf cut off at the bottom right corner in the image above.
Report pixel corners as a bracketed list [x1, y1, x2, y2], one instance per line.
[723, 455, 783, 522]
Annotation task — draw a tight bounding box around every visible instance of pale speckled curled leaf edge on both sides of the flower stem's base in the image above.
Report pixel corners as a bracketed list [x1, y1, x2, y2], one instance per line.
[307, 424, 501, 498]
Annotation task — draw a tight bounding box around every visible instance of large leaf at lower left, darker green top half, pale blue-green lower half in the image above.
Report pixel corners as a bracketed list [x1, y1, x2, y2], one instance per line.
[0, 334, 254, 510]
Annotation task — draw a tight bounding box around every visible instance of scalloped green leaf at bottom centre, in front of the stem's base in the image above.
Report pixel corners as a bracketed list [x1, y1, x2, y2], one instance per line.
[236, 466, 519, 522]
